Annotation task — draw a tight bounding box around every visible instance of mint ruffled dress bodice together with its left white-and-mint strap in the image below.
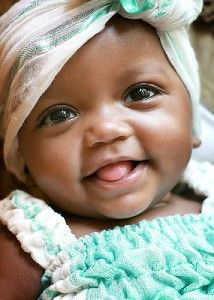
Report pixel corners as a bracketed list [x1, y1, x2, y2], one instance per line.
[0, 191, 214, 300]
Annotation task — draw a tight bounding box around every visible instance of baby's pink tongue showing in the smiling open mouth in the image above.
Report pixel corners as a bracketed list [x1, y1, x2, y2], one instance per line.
[96, 160, 133, 181]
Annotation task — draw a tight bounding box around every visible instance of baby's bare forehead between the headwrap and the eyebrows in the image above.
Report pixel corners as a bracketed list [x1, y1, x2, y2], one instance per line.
[38, 15, 171, 97]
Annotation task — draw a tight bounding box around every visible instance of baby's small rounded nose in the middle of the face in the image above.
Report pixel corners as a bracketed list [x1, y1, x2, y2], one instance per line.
[85, 108, 133, 147]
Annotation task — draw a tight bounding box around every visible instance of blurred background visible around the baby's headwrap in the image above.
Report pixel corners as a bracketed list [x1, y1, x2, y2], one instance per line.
[0, 0, 214, 199]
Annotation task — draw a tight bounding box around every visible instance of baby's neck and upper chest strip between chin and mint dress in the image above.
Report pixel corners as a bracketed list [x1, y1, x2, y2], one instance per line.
[65, 194, 201, 237]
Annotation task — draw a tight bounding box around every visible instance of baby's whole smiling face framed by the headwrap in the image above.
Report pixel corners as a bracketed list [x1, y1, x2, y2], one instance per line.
[19, 17, 195, 219]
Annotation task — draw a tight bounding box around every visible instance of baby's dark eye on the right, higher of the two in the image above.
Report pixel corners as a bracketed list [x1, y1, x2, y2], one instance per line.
[125, 84, 160, 102]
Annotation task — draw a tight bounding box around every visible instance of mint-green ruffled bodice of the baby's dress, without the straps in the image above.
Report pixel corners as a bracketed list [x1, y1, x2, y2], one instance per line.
[40, 214, 214, 300]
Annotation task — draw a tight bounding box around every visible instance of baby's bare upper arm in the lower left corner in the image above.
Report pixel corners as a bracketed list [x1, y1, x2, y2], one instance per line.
[0, 223, 43, 300]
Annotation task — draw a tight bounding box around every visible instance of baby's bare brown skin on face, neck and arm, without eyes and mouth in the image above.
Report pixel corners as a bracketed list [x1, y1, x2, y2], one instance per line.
[0, 17, 201, 300]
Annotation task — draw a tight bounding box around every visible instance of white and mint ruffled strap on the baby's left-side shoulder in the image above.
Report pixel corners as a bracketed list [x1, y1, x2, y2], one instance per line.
[0, 190, 77, 269]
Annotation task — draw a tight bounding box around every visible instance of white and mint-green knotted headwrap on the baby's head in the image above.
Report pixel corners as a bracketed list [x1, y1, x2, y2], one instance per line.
[0, 0, 202, 180]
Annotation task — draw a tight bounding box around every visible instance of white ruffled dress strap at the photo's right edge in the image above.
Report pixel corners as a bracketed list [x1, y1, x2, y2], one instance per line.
[182, 159, 214, 214]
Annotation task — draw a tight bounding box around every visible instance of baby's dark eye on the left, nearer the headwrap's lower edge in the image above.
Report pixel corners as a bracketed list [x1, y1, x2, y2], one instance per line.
[39, 105, 77, 126]
